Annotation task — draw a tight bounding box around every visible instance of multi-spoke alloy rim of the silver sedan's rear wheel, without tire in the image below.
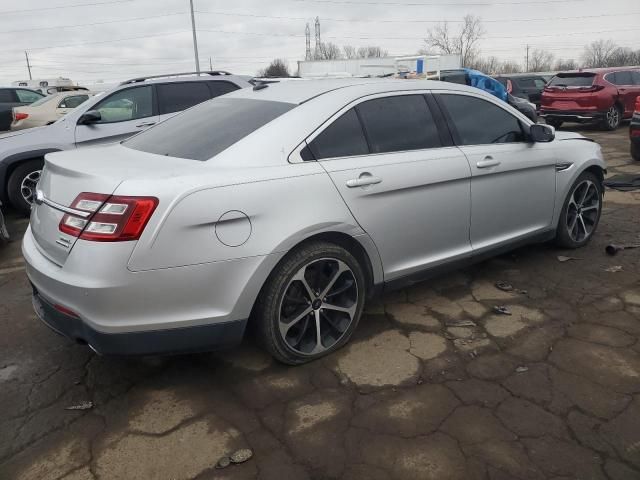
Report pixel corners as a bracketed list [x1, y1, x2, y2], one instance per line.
[278, 258, 358, 355]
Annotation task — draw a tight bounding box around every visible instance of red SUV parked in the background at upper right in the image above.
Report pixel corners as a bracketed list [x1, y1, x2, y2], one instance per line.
[540, 67, 640, 130]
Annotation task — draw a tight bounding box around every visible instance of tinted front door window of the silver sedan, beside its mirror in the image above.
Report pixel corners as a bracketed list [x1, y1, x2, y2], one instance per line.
[439, 94, 526, 145]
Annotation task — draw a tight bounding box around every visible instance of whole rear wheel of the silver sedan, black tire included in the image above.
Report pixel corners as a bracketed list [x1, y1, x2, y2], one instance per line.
[254, 241, 366, 365]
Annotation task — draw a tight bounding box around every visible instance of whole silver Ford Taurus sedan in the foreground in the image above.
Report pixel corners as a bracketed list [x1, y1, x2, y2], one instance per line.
[23, 79, 605, 364]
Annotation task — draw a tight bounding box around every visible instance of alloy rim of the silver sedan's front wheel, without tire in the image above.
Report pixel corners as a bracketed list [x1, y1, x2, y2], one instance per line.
[567, 180, 600, 242]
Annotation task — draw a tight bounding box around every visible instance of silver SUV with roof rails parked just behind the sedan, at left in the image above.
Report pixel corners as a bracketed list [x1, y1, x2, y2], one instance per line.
[0, 71, 251, 215]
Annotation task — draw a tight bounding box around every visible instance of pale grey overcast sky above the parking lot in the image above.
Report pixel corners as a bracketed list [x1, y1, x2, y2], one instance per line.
[0, 0, 640, 84]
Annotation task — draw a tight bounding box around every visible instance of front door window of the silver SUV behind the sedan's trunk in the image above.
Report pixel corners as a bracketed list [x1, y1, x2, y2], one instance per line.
[92, 85, 153, 123]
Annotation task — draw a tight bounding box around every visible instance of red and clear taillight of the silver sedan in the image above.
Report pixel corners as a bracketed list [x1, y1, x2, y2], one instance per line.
[59, 192, 158, 242]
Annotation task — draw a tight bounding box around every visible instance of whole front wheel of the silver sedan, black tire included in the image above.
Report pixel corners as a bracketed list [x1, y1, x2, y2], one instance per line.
[556, 172, 603, 248]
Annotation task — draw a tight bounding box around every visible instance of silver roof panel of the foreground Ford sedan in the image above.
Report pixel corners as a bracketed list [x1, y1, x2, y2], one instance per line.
[226, 78, 488, 104]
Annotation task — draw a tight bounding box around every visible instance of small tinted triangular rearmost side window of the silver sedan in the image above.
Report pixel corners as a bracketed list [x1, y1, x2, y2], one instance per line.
[309, 108, 369, 160]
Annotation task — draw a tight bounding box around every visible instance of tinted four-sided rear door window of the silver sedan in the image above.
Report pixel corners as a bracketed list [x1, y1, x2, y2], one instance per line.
[356, 95, 441, 153]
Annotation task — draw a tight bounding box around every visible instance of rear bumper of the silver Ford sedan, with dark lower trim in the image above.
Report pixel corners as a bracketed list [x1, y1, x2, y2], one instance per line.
[22, 228, 281, 355]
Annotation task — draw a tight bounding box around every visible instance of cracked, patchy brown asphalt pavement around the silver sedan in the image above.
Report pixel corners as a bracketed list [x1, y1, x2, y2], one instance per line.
[0, 127, 640, 480]
